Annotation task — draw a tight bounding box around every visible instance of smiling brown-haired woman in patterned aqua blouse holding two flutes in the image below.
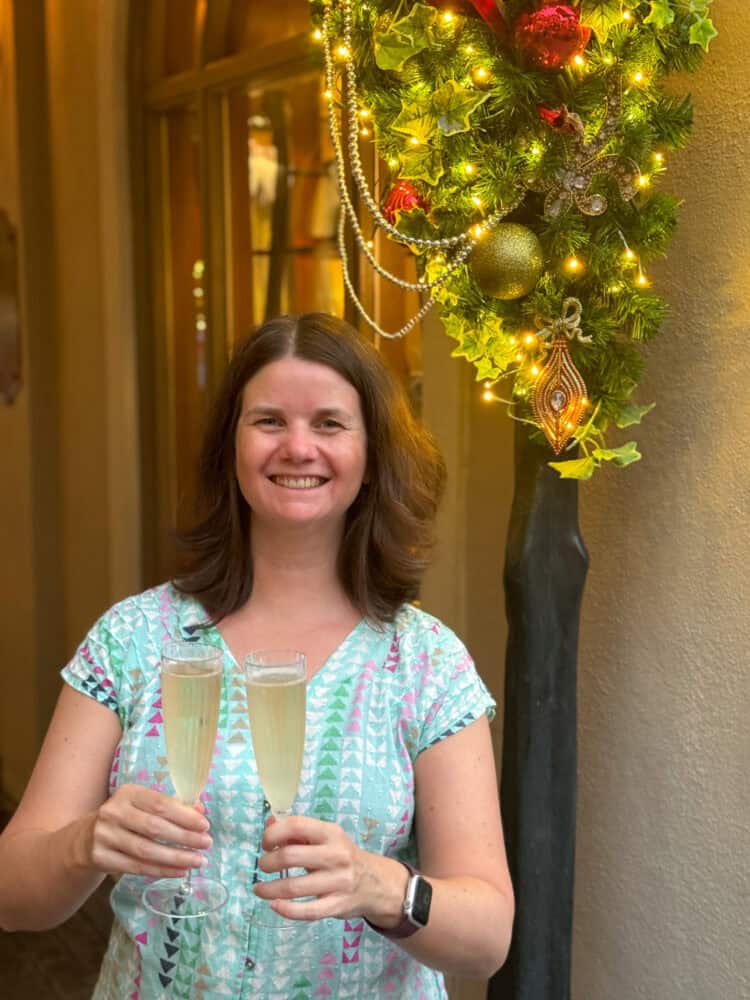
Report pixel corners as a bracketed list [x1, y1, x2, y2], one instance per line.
[0, 313, 513, 1000]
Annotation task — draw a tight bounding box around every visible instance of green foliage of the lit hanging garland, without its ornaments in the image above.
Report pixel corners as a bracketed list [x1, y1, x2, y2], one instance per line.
[313, 0, 716, 480]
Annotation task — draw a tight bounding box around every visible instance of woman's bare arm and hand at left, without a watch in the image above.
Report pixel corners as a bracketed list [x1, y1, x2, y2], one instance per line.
[0, 684, 210, 930]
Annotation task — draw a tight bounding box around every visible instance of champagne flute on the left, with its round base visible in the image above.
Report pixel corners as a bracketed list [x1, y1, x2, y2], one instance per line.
[143, 641, 229, 918]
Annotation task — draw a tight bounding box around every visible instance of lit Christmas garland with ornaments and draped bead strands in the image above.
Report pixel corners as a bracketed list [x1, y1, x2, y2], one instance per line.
[312, 0, 716, 479]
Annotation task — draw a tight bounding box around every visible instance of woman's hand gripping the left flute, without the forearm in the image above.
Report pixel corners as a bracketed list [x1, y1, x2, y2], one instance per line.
[76, 785, 211, 878]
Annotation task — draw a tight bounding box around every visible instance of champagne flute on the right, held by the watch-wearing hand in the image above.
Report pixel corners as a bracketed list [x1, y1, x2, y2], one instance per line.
[245, 649, 306, 926]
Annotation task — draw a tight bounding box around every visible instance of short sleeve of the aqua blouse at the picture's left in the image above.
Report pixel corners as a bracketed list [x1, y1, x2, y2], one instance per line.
[61, 606, 125, 723]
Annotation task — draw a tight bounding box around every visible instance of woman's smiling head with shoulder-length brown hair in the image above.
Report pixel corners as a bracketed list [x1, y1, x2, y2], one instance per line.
[178, 313, 445, 621]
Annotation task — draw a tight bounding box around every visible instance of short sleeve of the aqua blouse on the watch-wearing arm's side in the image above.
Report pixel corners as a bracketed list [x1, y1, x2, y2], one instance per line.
[417, 619, 495, 753]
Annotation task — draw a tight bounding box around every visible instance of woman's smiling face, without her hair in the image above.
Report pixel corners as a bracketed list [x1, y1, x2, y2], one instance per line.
[235, 357, 367, 529]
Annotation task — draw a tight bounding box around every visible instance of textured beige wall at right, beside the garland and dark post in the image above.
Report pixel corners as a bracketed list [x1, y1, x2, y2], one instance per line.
[573, 9, 750, 1000]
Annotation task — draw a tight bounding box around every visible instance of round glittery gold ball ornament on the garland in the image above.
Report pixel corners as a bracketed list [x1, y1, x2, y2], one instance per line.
[469, 222, 544, 299]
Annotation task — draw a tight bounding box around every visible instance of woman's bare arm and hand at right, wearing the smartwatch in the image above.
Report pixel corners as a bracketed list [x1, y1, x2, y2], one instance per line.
[255, 717, 513, 977]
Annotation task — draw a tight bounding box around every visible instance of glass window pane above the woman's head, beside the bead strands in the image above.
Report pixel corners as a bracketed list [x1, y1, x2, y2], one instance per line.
[222, 74, 344, 337]
